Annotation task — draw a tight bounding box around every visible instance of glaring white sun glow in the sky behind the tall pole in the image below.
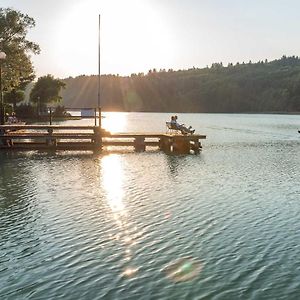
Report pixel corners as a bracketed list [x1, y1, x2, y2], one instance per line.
[57, 0, 176, 75]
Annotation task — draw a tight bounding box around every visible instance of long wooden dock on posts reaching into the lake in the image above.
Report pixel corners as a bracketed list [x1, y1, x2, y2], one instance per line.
[0, 125, 206, 154]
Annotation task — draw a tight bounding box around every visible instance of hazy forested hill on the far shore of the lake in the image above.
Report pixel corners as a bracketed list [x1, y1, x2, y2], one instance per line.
[61, 56, 300, 113]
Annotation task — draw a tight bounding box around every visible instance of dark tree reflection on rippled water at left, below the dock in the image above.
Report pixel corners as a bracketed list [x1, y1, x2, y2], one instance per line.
[0, 153, 41, 268]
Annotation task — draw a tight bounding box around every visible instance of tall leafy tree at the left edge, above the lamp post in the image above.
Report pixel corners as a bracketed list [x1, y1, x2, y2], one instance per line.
[0, 8, 40, 92]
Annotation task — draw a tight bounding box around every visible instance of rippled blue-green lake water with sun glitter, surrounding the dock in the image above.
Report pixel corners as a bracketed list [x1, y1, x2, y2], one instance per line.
[0, 113, 300, 299]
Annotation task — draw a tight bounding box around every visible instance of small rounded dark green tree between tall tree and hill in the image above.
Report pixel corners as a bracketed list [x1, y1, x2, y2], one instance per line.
[30, 75, 66, 106]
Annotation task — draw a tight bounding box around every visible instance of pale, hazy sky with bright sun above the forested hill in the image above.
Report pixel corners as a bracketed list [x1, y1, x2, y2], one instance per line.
[1, 0, 300, 78]
